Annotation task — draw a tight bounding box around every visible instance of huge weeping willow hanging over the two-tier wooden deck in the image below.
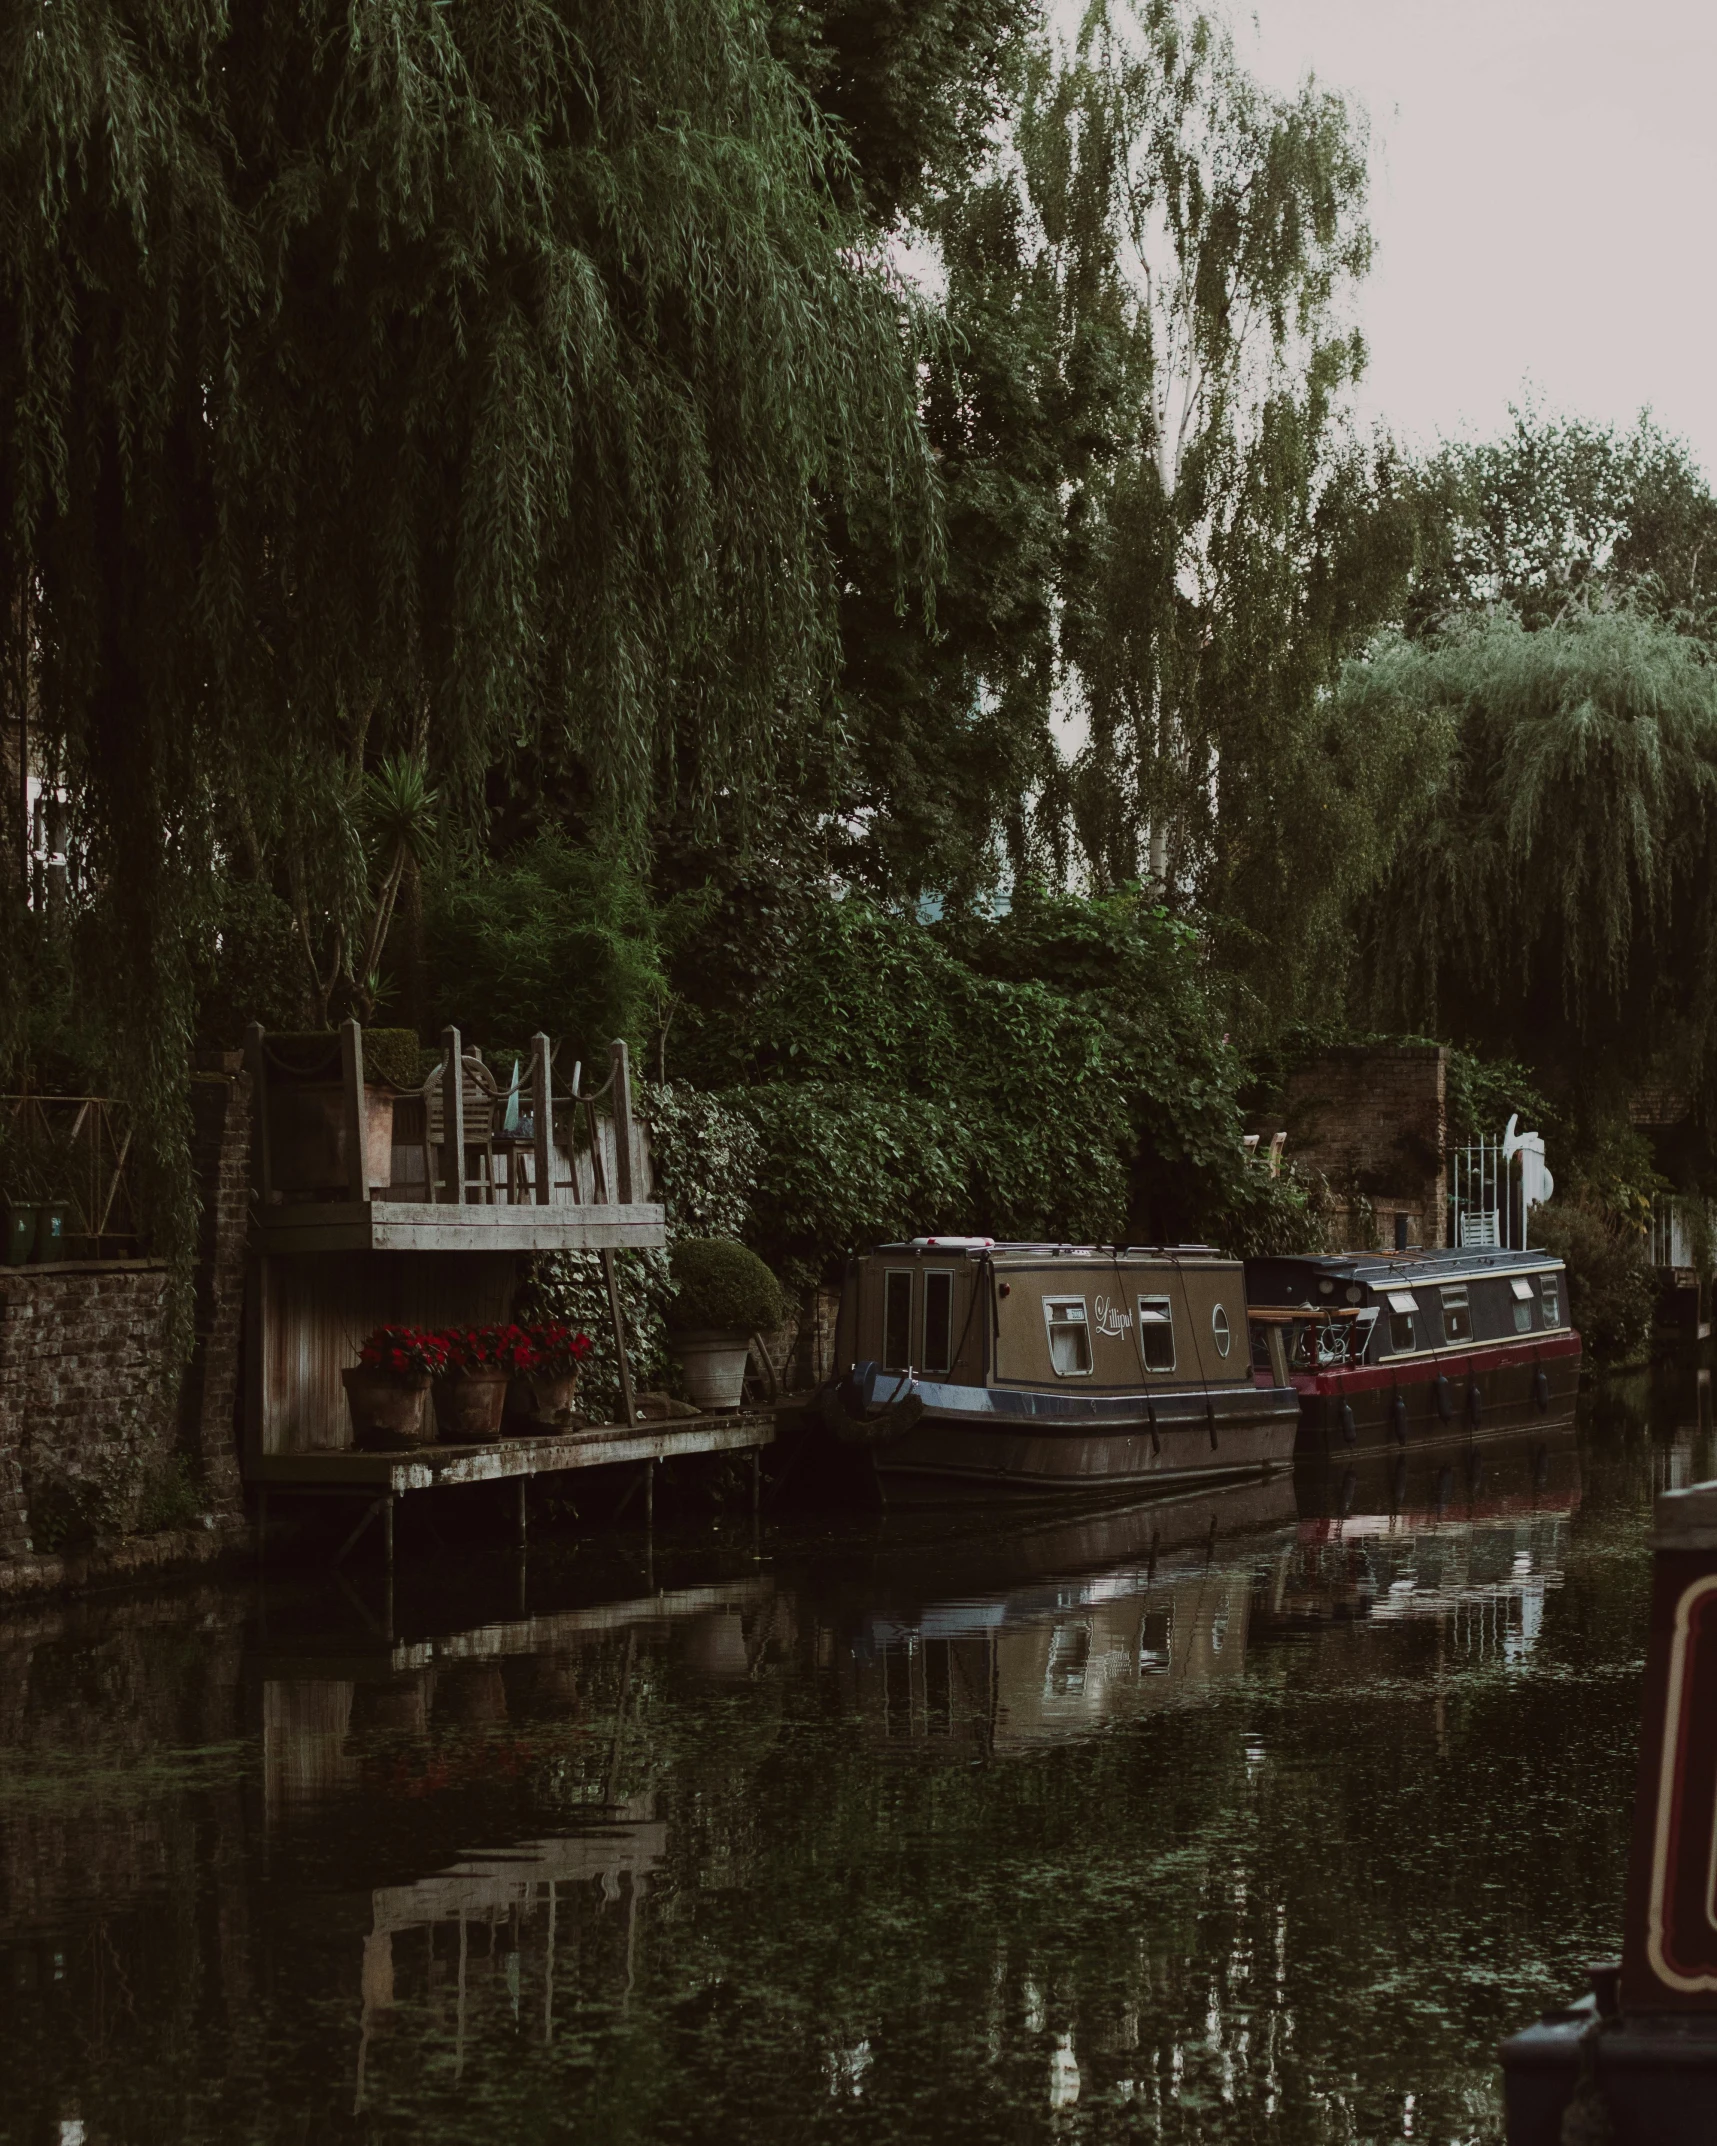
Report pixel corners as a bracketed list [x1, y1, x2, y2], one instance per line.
[0, 0, 929, 1240]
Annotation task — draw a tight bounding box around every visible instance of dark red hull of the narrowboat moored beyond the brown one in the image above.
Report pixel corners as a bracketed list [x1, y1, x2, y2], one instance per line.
[1294, 1333, 1580, 1461]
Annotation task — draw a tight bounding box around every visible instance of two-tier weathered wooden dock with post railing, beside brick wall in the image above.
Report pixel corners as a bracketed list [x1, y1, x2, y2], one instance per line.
[243, 1021, 798, 1571]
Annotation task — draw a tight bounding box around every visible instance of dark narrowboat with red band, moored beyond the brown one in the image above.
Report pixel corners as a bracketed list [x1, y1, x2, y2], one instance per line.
[1245, 1249, 1580, 1459]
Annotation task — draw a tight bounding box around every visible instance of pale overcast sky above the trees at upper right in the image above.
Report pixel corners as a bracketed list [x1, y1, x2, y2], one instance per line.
[1232, 0, 1717, 479]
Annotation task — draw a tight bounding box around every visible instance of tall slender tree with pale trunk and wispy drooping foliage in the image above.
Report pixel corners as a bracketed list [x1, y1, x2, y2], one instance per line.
[1058, 0, 1371, 918]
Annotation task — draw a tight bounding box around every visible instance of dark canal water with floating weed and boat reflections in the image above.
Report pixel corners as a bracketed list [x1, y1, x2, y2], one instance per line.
[0, 1371, 1713, 2146]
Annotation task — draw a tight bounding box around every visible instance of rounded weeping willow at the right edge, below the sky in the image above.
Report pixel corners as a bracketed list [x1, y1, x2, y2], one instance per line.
[1341, 609, 1717, 1101]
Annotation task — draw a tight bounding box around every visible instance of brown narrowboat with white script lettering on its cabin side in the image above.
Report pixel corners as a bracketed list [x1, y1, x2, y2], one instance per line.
[822, 1236, 1298, 1504]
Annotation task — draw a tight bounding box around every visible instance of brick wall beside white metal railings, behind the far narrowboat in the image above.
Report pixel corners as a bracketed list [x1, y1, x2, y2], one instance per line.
[1286, 1043, 1449, 1251]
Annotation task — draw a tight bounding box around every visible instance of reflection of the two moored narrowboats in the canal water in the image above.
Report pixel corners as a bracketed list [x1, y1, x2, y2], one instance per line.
[852, 1421, 1580, 1758]
